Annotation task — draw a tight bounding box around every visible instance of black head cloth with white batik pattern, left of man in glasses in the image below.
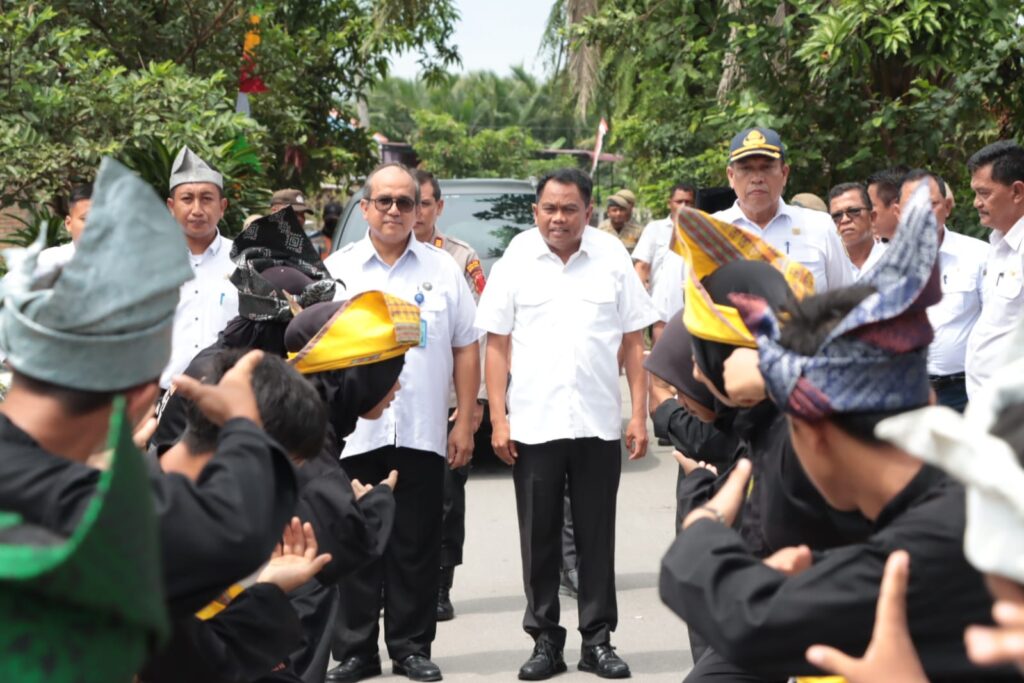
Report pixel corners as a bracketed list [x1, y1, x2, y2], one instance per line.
[231, 207, 336, 323]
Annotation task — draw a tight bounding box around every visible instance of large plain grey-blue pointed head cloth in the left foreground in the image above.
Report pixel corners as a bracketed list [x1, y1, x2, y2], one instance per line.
[0, 158, 195, 391]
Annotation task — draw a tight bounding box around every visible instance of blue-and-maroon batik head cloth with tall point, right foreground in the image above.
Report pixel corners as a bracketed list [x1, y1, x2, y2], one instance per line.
[730, 185, 942, 420]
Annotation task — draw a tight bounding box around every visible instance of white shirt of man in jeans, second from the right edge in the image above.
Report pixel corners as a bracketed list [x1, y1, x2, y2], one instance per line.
[928, 227, 988, 377]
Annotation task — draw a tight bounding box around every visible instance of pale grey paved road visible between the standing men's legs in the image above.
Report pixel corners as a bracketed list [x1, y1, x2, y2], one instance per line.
[344, 376, 691, 683]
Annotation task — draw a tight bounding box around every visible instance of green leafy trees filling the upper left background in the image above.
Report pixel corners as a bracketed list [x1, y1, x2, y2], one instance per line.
[0, 0, 458, 216]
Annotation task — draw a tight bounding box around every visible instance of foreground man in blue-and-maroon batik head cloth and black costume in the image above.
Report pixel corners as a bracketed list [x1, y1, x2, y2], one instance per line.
[660, 184, 1007, 681]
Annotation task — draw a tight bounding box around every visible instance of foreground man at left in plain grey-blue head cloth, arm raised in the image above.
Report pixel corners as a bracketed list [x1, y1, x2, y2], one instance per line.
[0, 154, 295, 630]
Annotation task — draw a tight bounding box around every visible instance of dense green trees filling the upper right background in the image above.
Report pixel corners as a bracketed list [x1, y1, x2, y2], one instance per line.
[561, 0, 1024, 237]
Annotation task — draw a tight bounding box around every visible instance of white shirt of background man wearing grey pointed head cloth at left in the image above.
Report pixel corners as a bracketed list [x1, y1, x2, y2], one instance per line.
[160, 232, 239, 389]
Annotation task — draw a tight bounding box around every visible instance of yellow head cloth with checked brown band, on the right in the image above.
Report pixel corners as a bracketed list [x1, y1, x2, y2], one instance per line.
[672, 207, 814, 348]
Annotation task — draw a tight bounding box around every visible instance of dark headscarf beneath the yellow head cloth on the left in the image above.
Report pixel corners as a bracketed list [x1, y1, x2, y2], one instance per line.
[285, 301, 406, 439]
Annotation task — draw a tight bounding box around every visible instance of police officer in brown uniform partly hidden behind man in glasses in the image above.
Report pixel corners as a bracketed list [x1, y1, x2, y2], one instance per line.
[413, 170, 487, 622]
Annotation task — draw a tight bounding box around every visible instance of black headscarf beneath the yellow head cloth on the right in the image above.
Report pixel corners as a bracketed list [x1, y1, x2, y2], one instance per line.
[693, 261, 793, 401]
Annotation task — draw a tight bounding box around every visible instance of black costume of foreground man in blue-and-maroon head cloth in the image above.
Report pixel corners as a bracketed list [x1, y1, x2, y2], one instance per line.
[659, 466, 1019, 681]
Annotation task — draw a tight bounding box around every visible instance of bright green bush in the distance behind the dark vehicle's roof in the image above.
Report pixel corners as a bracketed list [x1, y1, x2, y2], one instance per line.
[411, 111, 544, 178]
